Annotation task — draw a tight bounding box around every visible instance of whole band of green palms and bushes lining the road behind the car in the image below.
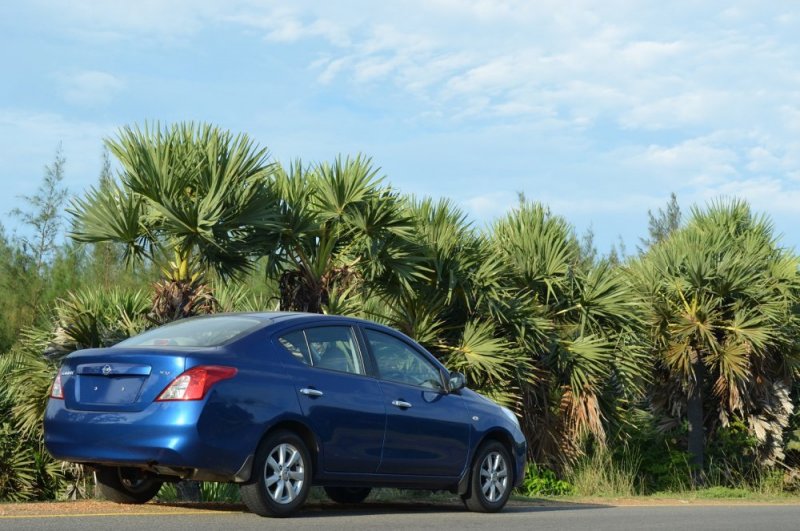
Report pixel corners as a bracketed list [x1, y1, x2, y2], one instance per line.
[0, 124, 800, 501]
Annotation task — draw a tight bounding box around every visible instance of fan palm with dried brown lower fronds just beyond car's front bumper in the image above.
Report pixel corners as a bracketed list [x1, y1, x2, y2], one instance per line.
[490, 199, 648, 466]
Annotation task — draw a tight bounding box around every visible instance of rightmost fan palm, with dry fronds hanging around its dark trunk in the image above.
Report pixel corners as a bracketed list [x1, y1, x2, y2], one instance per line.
[632, 200, 800, 481]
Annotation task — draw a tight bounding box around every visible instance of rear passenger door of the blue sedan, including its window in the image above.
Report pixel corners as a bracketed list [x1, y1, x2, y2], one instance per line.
[277, 325, 386, 473]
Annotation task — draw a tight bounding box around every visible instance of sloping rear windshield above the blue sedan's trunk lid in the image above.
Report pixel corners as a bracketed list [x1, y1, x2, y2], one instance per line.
[116, 316, 262, 347]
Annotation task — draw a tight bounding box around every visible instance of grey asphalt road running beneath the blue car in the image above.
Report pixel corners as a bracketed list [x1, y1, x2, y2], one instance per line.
[0, 504, 800, 531]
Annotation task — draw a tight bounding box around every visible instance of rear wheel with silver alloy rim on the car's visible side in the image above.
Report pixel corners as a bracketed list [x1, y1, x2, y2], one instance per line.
[239, 431, 312, 517]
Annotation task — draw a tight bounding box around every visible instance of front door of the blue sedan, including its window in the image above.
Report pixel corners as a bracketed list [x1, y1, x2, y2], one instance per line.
[364, 328, 470, 476]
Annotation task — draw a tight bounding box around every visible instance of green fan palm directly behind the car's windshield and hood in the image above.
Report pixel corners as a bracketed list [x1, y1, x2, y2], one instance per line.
[348, 198, 525, 405]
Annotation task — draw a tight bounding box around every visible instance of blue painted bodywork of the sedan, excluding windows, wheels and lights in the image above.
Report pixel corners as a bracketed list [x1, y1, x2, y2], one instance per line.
[45, 313, 526, 488]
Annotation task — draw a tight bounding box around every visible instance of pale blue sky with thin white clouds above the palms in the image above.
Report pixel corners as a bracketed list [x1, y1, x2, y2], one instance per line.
[0, 0, 800, 253]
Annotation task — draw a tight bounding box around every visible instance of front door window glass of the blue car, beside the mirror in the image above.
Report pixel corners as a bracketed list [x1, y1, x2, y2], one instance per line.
[364, 329, 444, 391]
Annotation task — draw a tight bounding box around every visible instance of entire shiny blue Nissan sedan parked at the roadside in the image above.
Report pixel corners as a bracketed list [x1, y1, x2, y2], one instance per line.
[44, 312, 526, 516]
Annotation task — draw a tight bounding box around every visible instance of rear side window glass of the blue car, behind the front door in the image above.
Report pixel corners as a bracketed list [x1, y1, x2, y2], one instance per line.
[278, 326, 366, 374]
